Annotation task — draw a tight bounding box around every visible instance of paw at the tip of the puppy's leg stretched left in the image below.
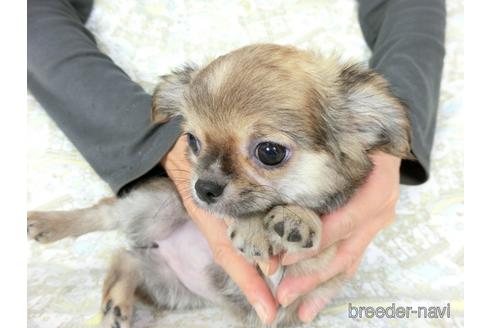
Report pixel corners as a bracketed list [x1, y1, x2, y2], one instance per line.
[27, 211, 65, 244]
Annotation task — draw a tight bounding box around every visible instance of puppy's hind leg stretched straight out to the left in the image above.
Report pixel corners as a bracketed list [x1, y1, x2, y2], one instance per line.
[27, 178, 188, 246]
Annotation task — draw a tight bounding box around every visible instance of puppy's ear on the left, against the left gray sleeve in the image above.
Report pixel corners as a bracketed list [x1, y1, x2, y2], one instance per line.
[150, 64, 197, 124]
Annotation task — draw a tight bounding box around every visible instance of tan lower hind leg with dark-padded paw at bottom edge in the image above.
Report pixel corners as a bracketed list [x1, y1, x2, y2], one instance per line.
[102, 250, 142, 328]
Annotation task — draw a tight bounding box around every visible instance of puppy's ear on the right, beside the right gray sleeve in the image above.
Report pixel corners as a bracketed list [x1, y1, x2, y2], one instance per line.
[338, 65, 413, 159]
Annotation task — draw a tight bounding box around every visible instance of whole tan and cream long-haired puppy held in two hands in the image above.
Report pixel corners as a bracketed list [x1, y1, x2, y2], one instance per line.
[27, 44, 411, 327]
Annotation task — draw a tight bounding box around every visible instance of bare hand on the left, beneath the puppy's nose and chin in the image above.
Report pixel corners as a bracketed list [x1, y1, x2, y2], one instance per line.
[161, 136, 278, 324]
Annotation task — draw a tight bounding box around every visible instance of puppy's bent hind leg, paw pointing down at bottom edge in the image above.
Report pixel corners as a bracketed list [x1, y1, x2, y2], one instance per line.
[101, 248, 211, 328]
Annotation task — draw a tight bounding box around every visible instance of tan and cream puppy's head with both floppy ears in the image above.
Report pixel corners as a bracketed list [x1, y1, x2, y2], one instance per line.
[152, 45, 410, 217]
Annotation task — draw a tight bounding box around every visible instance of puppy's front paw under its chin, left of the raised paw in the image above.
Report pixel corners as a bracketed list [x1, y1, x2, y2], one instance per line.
[227, 218, 279, 262]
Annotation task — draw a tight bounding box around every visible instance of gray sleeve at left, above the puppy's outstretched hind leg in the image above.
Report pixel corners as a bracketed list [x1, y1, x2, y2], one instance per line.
[27, 0, 180, 192]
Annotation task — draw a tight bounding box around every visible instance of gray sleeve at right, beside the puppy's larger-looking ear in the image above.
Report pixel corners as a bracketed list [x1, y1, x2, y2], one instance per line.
[359, 0, 446, 184]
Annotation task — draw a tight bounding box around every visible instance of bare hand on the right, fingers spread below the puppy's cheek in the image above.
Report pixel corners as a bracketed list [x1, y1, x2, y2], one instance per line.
[277, 152, 401, 322]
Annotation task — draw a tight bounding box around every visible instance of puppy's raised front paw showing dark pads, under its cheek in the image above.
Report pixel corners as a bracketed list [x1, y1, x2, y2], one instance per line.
[265, 205, 321, 252]
